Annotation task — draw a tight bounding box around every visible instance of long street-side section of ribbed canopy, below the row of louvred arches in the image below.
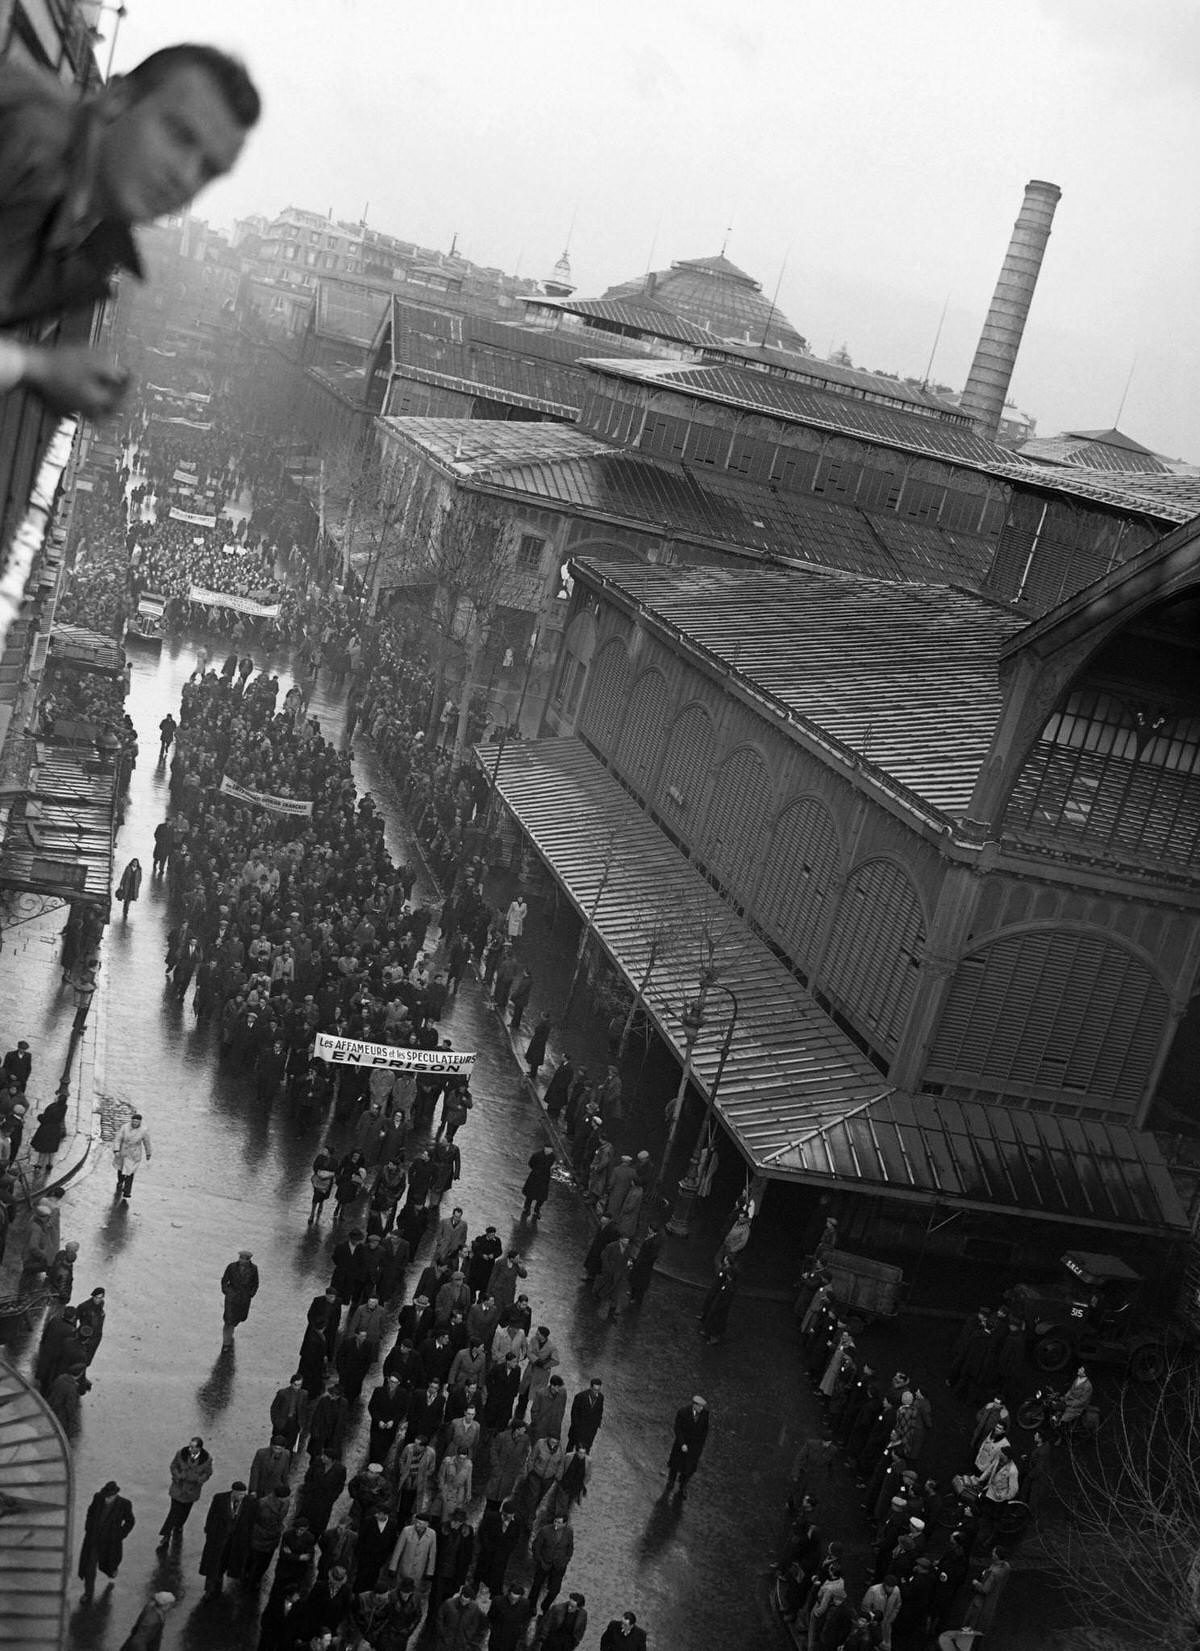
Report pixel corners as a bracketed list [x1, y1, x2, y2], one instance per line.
[479, 738, 886, 1164]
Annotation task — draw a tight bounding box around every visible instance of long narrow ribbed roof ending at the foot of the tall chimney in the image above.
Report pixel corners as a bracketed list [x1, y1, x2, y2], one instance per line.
[590, 362, 1013, 472]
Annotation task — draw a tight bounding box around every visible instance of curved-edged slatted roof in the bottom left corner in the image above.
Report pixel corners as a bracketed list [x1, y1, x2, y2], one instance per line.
[0, 1355, 73, 1651]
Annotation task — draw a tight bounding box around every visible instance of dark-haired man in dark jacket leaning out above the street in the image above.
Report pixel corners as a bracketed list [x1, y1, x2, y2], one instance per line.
[0, 45, 261, 418]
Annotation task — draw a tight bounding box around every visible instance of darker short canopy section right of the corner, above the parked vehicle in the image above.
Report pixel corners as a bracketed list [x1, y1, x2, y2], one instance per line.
[772, 1093, 1188, 1232]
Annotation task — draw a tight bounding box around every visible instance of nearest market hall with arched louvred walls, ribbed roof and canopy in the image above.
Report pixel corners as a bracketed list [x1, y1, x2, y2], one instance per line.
[485, 527, 1200, 1253]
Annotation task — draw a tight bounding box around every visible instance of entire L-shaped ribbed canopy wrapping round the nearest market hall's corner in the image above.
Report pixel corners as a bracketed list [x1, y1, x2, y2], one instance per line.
[477, 738, 1187, 1232]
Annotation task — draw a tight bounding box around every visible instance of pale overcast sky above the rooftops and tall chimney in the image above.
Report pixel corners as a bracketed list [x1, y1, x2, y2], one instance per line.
[101, 0, 1200, 462]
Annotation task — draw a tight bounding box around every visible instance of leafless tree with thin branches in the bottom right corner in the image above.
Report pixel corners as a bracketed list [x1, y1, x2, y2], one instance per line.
[1025, 1362, 1200, 1651]
